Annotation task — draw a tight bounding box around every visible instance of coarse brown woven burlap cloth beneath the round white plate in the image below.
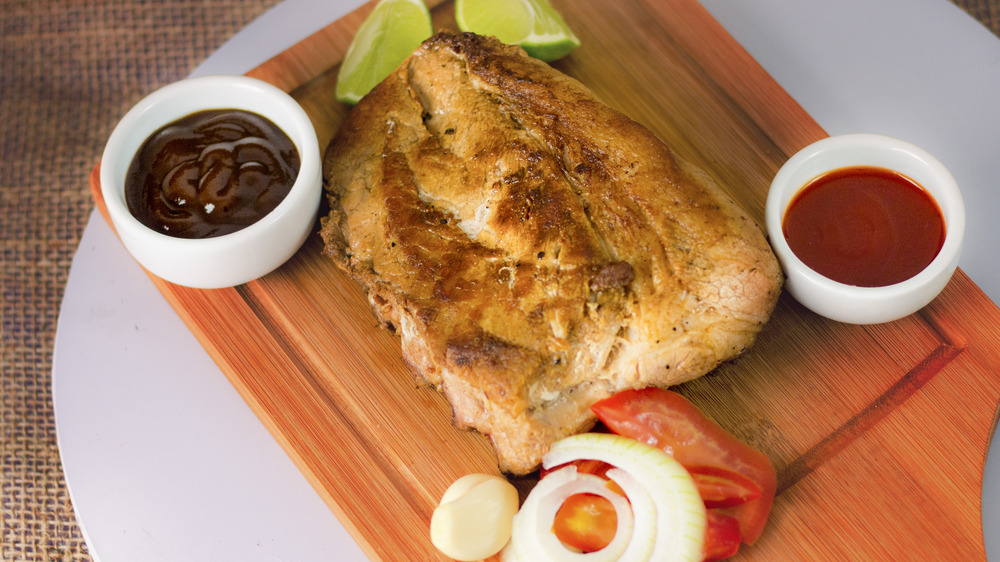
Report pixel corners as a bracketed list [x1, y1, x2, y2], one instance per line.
[0, 0, 1000, 561]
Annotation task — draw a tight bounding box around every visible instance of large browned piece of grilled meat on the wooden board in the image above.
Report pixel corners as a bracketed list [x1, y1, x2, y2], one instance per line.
[321, 33, 783, 474]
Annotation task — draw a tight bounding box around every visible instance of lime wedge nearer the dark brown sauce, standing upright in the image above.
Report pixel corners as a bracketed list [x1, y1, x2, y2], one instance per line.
[334, 0, 434, 105]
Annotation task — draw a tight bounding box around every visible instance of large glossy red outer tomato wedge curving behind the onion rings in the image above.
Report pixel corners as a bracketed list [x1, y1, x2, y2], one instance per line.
[591, 387, 777, 544]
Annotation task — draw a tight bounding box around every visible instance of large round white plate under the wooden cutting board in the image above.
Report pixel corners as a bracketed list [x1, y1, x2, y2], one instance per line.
[53, 0, 1000, 562]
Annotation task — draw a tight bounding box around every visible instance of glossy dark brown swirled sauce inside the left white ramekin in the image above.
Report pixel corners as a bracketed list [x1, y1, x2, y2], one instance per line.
[125, 109, 300, 238]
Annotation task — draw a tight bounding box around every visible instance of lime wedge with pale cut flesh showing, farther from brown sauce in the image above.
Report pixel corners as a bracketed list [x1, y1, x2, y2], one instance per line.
[455, 0, 580, 61]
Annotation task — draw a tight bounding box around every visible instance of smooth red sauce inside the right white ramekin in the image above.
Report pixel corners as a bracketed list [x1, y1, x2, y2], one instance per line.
[782, 166, 945, 287]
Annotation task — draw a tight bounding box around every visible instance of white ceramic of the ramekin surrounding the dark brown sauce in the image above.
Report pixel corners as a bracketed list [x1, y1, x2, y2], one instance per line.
[100, 75, 322, 289]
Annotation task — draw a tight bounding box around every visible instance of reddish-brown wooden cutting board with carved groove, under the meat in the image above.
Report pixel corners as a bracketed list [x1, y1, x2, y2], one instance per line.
[91, 0, 1000, 561]
